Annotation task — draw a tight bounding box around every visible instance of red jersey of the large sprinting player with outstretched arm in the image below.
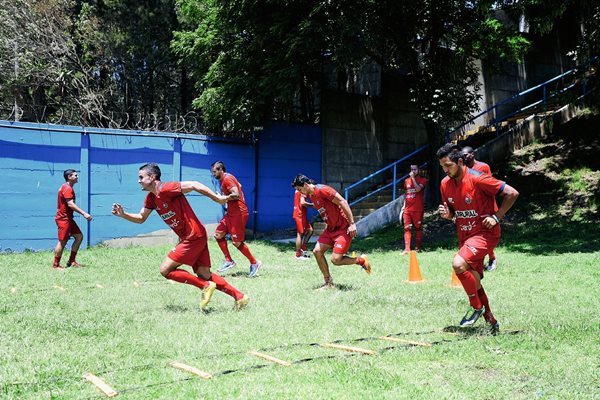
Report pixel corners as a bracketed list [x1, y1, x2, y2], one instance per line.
[144, 182, 206, 240]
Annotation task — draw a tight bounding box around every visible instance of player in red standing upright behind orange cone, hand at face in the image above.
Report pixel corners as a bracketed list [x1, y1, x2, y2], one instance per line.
[402, 165, 427, 254]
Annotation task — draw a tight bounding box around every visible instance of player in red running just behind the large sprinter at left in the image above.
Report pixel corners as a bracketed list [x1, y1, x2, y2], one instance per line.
[211, 161, 262, 278]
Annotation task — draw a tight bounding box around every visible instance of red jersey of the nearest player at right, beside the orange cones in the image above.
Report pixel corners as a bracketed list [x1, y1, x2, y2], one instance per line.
[440, 167, 506, 243]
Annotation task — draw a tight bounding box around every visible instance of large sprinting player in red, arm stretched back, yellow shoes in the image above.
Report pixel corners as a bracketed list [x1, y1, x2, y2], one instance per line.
[112, 163, 249, 310]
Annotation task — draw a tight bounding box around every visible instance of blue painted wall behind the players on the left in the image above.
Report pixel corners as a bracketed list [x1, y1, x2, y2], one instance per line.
[0, 121, 321, 251]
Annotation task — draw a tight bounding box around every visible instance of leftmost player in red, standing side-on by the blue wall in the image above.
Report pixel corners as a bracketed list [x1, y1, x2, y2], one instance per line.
[52, 169, 92, 270]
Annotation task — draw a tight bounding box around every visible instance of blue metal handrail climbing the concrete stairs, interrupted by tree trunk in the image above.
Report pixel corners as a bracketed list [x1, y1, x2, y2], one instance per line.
[344, 58, 597, 209]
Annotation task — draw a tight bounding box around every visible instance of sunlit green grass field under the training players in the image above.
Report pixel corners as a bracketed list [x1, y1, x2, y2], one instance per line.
[0, 214, 600, 399]
